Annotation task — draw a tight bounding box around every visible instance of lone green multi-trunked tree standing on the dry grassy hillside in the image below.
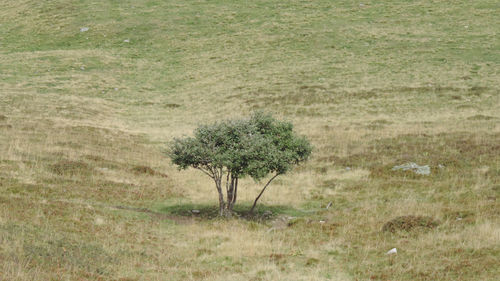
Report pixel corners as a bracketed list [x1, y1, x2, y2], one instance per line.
[168, 112, 312, 216]
